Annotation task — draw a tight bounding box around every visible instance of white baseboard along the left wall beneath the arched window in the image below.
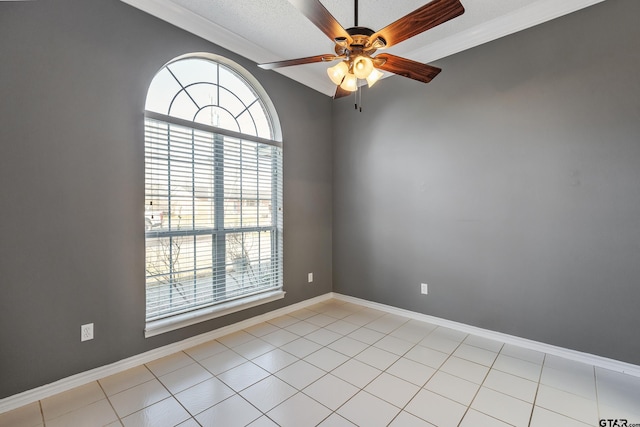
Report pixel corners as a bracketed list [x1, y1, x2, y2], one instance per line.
[0, 293, 331, 414]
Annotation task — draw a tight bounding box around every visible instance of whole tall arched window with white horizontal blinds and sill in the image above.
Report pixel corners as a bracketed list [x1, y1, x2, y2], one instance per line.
[145, 54, 284, 336]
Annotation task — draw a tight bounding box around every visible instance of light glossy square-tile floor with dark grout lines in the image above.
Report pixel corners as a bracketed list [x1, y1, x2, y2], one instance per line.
[0, 300, 640, 427]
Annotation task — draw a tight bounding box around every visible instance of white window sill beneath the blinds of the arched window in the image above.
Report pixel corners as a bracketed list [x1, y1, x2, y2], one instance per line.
[144, 290, 285, 338]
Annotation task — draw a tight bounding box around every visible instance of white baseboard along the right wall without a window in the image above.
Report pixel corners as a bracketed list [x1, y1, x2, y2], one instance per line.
[331, 293, 640, 377]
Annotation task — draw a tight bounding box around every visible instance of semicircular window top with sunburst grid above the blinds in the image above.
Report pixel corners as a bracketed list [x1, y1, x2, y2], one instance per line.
[145, 53, 282, 141]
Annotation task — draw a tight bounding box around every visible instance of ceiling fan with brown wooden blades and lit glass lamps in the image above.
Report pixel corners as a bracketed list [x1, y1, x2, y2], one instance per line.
[259, 0, 464, 99]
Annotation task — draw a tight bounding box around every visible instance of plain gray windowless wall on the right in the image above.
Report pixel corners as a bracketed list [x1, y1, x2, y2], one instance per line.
[333, 0, 640, 364]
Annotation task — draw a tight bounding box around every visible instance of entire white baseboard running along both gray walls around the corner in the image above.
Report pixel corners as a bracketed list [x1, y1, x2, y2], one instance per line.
[0, 292, 640, 413]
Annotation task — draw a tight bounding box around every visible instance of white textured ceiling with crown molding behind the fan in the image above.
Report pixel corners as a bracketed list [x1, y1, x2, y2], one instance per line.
[122, 0, 605, 96]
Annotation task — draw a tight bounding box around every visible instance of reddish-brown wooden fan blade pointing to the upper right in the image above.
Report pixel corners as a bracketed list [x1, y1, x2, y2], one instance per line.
[371, 0, 464, 47]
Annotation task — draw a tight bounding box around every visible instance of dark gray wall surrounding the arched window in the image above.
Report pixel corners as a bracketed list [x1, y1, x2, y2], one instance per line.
[0, 0, 332, 398]
